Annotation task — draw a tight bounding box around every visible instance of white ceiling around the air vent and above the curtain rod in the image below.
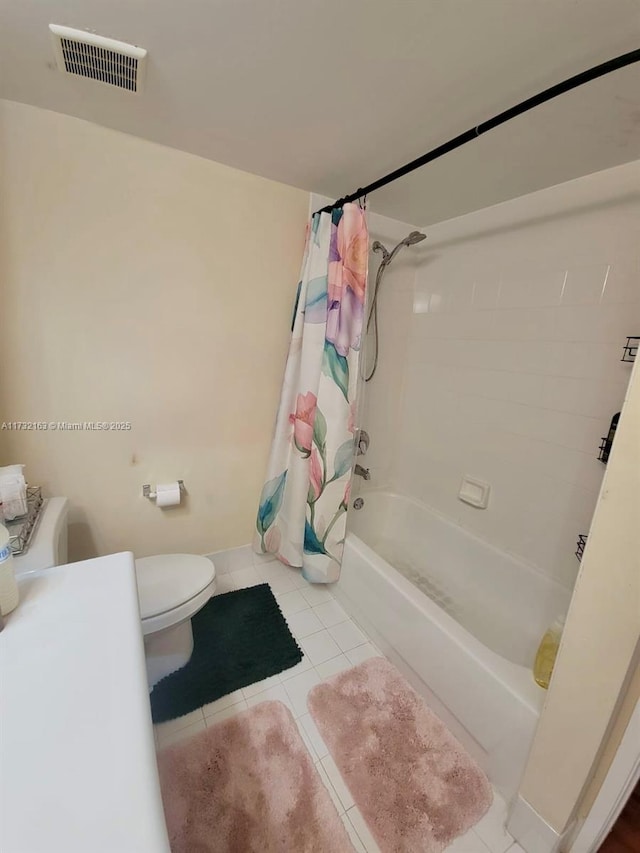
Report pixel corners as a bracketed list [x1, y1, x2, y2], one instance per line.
[0, 0, 640, 225]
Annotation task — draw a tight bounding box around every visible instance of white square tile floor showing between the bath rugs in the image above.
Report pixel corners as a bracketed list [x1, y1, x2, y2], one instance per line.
[155, 547, 524, 853]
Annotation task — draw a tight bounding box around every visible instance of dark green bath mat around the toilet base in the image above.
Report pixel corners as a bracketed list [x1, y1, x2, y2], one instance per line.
[151, 583, 302, 723]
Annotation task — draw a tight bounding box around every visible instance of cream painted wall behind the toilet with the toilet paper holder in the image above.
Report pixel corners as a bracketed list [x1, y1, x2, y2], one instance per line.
[0, 102, 309, 559]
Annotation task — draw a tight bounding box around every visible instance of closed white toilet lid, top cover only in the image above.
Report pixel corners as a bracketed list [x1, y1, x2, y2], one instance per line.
[136, 554, 216, 619]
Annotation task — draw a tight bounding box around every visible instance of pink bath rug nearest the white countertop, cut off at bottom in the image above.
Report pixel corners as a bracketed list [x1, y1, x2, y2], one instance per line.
[158, 702, 353, 853]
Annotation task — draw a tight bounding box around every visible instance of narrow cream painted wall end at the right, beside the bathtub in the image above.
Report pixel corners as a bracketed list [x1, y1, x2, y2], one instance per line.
[520, 356, 640, 833]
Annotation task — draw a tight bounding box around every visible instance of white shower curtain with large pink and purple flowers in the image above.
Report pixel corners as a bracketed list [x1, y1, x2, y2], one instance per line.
[254, 204, 369, 583]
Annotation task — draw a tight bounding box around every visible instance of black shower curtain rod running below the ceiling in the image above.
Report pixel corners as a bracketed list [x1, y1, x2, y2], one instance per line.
[314, 50, 640, 215]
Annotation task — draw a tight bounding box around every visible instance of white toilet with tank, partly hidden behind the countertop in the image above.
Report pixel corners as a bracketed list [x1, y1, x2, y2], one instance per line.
[14, 498, 216, 689]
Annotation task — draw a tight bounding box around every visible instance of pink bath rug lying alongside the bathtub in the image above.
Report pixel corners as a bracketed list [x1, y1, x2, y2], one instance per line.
[307, 657, 493, 853]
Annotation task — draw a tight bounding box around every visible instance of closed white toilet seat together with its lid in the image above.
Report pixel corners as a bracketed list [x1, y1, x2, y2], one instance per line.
[135, 554, 216, 636]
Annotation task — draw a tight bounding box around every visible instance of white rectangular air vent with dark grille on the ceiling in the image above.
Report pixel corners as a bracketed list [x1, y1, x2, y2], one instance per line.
[49, 24, 147, 93]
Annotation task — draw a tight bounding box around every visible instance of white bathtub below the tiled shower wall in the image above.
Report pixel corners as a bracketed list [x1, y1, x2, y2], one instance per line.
[334, 492, 571, 798]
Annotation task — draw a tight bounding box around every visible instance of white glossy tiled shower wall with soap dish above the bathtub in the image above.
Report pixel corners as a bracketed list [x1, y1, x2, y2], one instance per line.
[388, 163, 640, 586]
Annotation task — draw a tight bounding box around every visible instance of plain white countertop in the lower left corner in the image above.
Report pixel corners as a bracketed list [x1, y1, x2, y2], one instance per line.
[0, 553, 169, 853]
